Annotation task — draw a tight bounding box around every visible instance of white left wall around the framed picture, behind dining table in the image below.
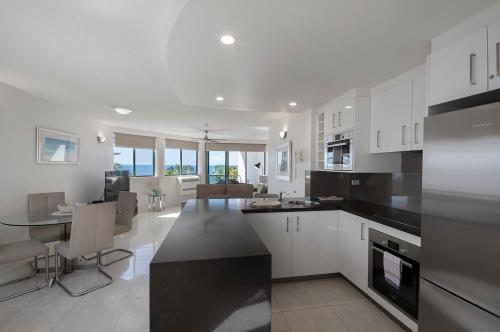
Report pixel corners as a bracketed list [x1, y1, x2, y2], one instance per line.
[0, 83, 113, 243]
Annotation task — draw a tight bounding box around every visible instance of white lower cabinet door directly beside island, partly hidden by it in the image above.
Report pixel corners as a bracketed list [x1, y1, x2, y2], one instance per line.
[246, 212, 292, 278]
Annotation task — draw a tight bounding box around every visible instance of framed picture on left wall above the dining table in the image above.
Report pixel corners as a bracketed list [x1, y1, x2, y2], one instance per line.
[36, 128, 80, 164]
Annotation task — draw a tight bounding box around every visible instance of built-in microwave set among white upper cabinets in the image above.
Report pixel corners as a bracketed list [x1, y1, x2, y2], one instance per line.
[325, 130, 354, 171]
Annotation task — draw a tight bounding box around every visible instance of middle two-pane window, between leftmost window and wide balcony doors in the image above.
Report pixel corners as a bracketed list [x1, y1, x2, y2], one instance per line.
[164, 148, 198, 175]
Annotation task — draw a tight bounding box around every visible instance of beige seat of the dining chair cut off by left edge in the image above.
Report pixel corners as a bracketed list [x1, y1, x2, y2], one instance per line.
[0, 240, 49, 264]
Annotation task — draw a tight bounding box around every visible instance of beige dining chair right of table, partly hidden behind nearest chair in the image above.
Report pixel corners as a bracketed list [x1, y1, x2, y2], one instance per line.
[101, 191, 137, 266]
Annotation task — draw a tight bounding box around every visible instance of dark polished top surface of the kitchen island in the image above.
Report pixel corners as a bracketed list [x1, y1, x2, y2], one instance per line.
[151, 199, 270, 264]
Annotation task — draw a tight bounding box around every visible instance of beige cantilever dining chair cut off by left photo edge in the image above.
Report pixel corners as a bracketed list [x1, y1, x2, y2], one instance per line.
[0, 240, 49, 302]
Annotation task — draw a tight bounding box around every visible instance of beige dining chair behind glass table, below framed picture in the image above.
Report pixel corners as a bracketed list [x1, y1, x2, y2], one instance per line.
[28, 192, 66, 243]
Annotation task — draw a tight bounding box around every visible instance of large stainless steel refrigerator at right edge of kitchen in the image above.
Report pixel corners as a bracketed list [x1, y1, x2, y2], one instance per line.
[418, 104, 500, 332]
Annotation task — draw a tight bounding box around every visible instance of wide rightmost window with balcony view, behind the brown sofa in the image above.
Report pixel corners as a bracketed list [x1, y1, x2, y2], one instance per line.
[207, 151, 265, 184]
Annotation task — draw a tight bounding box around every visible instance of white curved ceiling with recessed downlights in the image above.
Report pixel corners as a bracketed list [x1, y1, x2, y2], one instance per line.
[0, 0, 498, 139]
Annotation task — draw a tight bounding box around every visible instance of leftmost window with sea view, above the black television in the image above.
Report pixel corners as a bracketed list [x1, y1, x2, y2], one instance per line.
[113, 147, 155, 176]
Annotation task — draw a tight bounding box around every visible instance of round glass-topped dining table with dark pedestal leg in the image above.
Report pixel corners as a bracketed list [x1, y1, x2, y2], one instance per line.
[0, 209, 74, 273]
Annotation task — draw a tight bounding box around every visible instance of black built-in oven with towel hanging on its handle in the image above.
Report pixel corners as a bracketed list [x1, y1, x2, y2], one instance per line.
[368, 228, 420, 322]
